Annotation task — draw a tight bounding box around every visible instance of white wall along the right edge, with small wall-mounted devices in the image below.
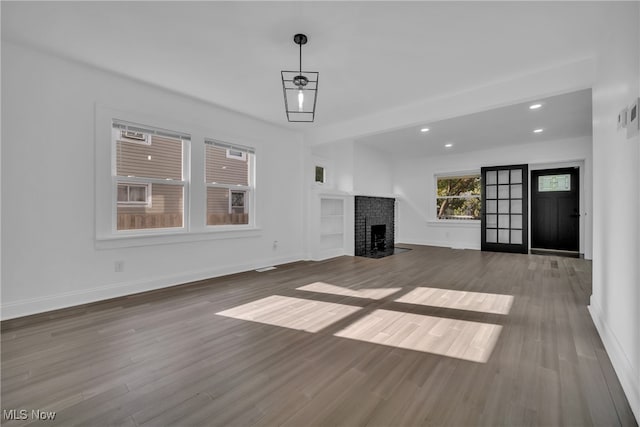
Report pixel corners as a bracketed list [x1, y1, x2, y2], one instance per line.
[589, 2, 640, 420]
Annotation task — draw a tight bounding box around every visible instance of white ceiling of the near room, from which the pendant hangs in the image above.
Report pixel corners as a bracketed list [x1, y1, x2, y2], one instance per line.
[1, 1, 607, 149]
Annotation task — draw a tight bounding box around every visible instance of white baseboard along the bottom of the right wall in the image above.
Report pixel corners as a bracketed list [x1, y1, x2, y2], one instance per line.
[587, 300, 640, 423]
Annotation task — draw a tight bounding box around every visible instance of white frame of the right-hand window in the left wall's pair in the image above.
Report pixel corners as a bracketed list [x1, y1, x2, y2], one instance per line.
[203, 137, 257, 227]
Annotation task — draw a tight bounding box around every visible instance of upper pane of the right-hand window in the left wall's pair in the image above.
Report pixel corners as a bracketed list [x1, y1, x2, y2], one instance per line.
[205, 144, 251, 186]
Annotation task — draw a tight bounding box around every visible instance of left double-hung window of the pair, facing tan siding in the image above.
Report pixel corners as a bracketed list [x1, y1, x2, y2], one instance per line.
[112, 120, 190, 231]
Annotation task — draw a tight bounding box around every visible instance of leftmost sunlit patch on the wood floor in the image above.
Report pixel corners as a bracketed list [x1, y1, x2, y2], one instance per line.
[216, 295, 361, 332]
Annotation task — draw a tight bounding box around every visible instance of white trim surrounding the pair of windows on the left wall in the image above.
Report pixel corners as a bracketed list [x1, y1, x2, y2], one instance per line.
[94, 103, 262, 250]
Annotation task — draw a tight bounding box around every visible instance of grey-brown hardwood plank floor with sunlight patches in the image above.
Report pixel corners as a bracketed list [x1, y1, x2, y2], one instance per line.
[1, 246, 636, 426]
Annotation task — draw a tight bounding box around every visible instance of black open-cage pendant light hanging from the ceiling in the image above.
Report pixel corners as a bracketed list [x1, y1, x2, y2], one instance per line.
[280, 34, 320, 122]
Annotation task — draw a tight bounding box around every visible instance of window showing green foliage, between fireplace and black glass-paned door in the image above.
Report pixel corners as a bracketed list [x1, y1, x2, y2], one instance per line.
[436, 174, 481, 220]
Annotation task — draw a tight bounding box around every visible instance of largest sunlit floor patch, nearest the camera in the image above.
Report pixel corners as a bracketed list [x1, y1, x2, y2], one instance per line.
[334, 310, 502, 363]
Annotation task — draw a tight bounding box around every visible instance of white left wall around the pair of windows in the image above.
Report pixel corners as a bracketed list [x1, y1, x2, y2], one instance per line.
[2, 42, 305, 319]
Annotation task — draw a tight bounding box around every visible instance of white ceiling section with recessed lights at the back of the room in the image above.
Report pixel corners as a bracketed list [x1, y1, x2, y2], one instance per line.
[356, 89, 592, 157]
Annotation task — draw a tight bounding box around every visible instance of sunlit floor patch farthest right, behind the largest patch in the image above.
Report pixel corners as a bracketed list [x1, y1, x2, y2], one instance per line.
[395, 287, 513, 314]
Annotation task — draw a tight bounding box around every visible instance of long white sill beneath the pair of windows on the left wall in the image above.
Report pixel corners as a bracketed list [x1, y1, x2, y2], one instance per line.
[95, 226, 262, 249]
